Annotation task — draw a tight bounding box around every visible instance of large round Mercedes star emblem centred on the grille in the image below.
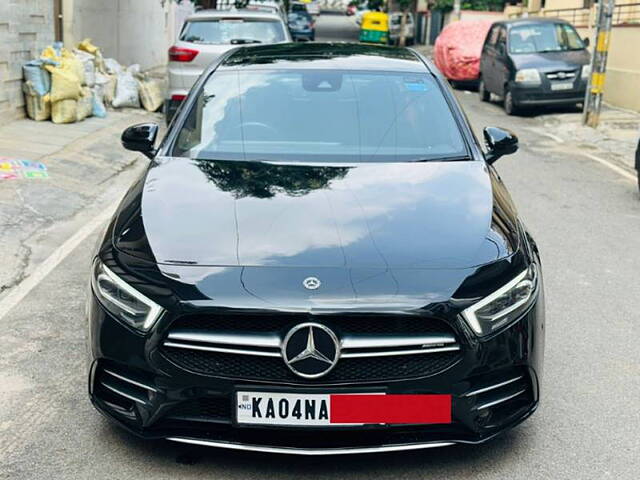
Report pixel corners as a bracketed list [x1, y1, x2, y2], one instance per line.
[282, 323, 340, 378]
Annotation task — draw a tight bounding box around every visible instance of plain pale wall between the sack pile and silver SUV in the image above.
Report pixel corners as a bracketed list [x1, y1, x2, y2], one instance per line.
[63, 0, 193, 70]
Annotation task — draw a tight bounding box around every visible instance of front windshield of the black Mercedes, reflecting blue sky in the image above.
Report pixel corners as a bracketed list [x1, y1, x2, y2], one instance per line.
[172, 70, 467, 162]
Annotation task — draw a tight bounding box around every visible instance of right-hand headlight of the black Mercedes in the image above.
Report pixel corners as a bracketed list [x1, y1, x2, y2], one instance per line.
[462, 263, 538, 337]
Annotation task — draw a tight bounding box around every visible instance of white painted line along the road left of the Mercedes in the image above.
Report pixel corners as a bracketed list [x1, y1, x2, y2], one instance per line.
[0, 202, 119, 320]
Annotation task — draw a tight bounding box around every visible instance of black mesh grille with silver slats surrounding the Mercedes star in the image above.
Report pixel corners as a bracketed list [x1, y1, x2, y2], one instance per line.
[160, 315, 461, 384]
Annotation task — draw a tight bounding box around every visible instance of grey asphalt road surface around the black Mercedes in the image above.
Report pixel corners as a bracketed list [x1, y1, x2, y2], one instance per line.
[0, 17, 640, 480]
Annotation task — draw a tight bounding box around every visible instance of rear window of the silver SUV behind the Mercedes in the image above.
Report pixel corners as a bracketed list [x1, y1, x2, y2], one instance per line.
[180, 18, 286, 44]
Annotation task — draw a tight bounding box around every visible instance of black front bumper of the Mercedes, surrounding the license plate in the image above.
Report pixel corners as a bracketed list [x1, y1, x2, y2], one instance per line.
[89, 293, 544, 455]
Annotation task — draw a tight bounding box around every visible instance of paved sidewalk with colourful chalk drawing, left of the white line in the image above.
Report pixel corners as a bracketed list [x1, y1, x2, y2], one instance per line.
[0, 109, 162, 298]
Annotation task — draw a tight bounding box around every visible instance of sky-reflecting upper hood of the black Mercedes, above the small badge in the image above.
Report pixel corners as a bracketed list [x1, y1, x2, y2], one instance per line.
[112, 158, 517, 271]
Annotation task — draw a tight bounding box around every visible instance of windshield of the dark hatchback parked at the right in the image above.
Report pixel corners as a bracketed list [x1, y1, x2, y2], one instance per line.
[509, 23, 585, 53]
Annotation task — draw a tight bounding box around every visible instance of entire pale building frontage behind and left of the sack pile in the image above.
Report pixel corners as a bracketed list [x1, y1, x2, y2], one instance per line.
[0, 0, 194, 125]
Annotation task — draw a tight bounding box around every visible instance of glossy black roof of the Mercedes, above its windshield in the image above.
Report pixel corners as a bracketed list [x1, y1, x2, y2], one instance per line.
[220, 42, 430, 73]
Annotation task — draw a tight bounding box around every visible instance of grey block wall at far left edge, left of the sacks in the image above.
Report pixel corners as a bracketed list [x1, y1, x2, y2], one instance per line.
[0, 0, 54, 125]
